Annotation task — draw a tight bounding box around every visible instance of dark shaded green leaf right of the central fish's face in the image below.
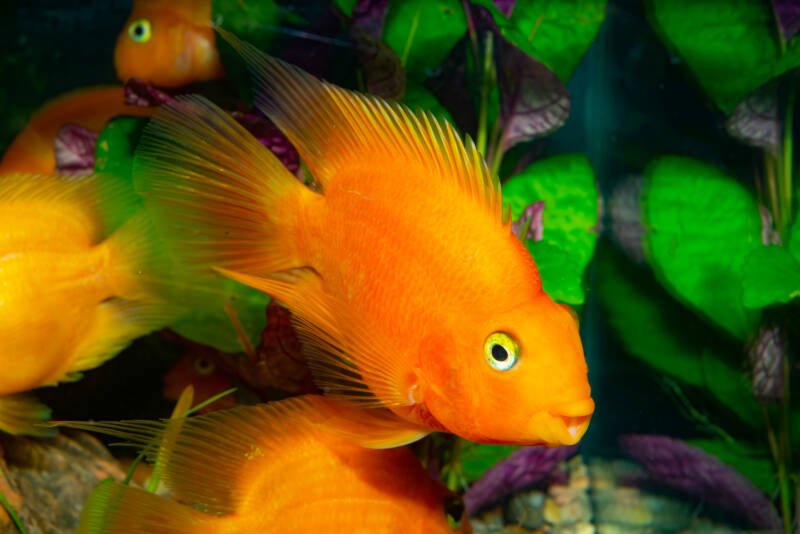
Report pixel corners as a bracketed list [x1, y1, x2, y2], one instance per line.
[596, 247, 763, 428]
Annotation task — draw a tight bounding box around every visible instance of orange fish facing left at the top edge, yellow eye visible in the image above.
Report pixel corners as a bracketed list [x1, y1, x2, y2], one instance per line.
[114, 0, 223, 87]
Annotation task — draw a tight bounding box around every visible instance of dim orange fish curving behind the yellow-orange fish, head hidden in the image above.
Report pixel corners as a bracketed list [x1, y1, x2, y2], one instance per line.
[0, 86, 155, 174]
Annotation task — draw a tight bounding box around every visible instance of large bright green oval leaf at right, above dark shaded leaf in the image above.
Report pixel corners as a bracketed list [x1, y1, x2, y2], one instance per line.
[642, 156, 762, 339]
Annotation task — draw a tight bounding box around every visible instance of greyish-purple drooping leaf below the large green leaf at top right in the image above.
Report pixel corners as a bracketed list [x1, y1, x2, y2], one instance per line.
[725, 84, 781, 155]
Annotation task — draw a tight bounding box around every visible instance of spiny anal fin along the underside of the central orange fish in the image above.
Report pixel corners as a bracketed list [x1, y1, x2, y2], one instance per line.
[221, 269, 412, 408]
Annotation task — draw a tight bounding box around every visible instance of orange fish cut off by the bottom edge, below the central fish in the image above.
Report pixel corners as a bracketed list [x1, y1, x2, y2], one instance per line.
[76, 396, 469, 534]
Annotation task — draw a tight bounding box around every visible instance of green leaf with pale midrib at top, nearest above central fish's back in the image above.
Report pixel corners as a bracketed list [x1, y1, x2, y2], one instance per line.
[383, 0, 467, 81]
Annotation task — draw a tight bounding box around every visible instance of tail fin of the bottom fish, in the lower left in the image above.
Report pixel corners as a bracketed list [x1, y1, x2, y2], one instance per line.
[77, 479, 212, 534]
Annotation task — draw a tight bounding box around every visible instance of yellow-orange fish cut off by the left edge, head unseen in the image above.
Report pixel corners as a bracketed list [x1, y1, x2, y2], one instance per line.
[0, 174, 178, 434]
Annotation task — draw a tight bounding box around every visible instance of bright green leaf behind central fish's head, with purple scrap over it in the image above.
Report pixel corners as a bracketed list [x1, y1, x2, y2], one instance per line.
[503, 154, 598, 305]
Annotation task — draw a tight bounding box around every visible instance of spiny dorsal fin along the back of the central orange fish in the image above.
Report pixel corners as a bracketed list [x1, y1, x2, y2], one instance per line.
[217, 28, 502, 222]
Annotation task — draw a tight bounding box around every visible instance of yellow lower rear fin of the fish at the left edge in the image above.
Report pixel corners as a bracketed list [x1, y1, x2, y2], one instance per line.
[68, 299, 177, 373]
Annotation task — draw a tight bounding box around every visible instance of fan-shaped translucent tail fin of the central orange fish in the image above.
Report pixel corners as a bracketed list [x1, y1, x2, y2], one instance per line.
[134, 96, 316, 282]
